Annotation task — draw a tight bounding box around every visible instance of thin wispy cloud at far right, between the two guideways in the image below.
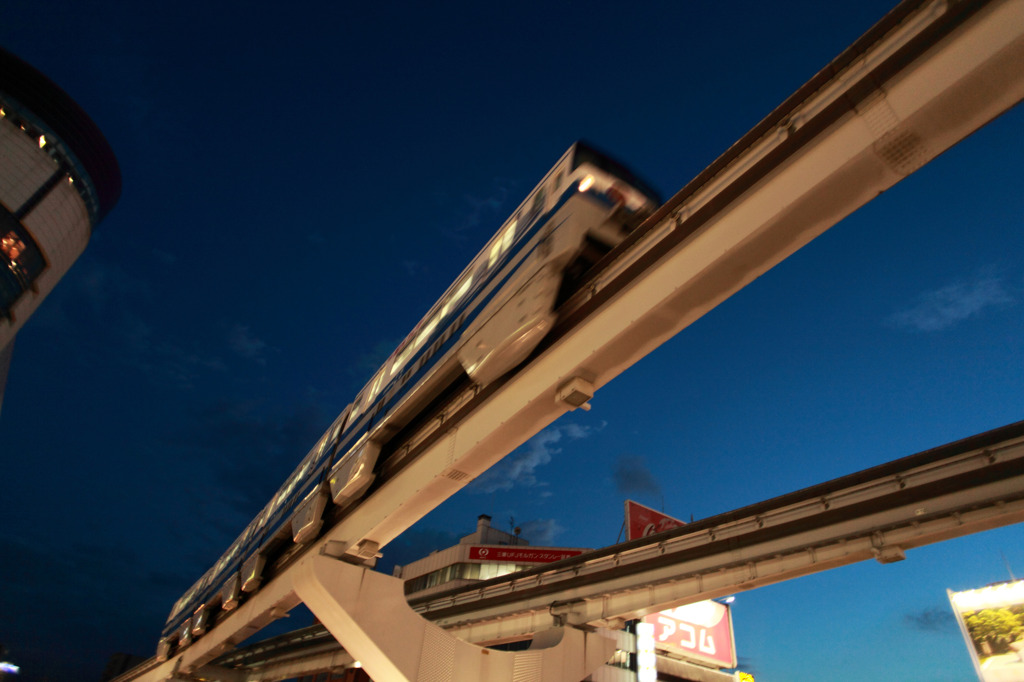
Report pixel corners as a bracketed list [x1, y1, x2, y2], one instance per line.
[889, 273, 1015, 332]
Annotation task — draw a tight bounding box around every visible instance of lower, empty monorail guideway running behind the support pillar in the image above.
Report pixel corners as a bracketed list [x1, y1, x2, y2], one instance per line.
[146, 422, 1024, 682]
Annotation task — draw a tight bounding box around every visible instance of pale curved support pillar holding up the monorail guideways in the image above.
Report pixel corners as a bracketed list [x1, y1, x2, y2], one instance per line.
[293, 555, 615, 682]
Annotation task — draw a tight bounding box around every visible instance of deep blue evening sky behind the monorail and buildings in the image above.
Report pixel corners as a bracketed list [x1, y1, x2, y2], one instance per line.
[0, 0, 1024, 682]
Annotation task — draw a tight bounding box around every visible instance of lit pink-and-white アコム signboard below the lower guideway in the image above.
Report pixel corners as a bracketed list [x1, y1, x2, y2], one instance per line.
[643, 600, 736, 668]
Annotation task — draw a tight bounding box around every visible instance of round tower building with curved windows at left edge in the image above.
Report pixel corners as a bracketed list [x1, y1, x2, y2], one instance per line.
[0, 49, 121, 404]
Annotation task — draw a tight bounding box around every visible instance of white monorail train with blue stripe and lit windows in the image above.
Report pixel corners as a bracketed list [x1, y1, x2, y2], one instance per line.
[158, 142, 660, 659]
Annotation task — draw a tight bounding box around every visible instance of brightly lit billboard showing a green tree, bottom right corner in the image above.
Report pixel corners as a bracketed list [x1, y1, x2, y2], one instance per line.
[946, 580, 1024, 682]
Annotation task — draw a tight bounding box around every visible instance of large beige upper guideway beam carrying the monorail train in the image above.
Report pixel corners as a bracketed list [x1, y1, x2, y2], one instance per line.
[139, 0, 1024, 680]
